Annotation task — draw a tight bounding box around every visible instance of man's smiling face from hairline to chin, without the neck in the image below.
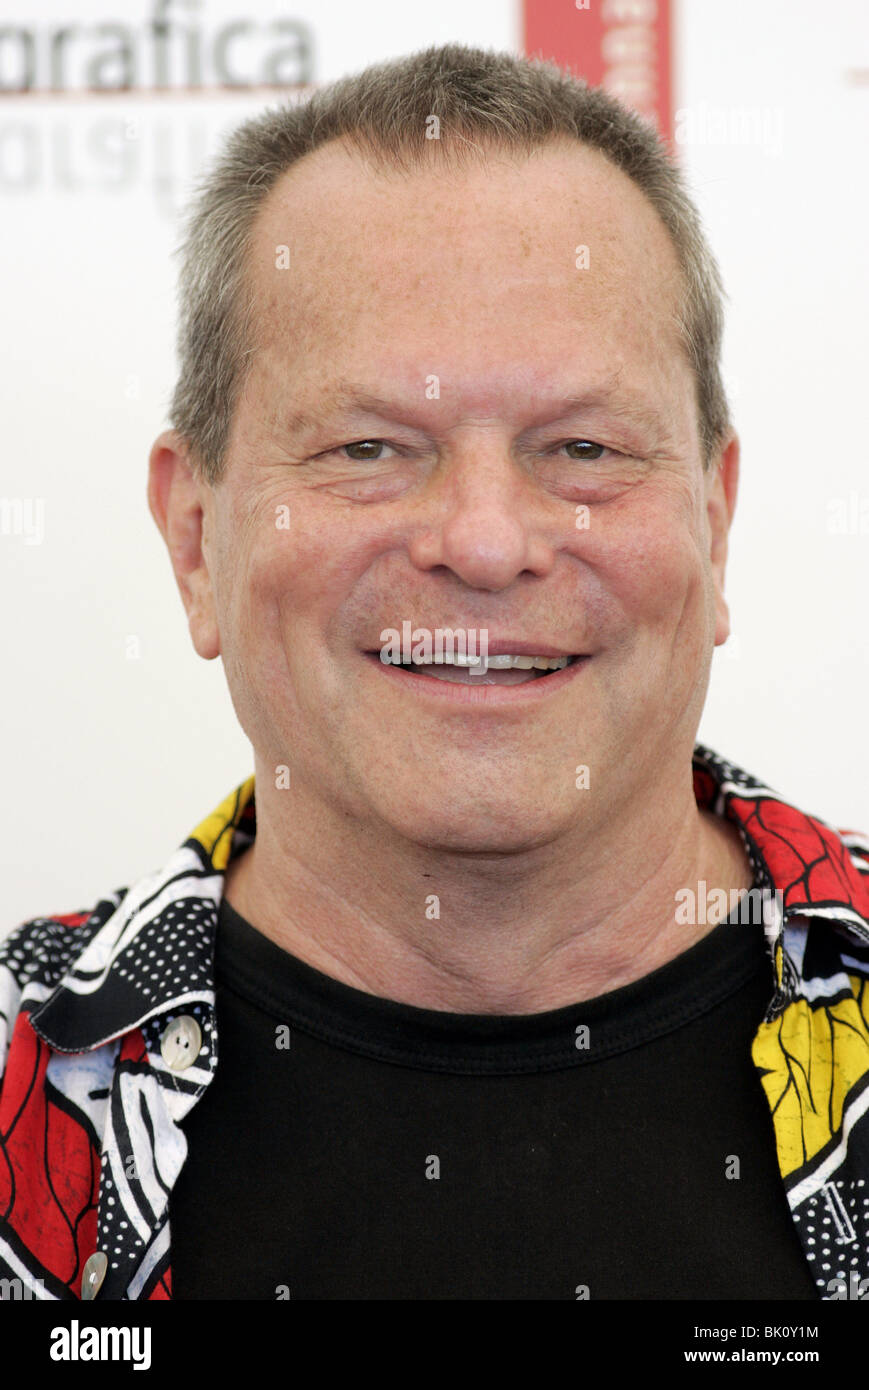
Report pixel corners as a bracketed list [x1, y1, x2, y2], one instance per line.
[180, 143, 729, 851]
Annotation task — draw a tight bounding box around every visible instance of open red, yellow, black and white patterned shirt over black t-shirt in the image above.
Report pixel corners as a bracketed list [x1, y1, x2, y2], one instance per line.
[0, 744, 869, 1300]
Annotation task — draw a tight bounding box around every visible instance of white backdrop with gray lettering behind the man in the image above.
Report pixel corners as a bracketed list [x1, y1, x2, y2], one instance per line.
[0, 0, 869, 935]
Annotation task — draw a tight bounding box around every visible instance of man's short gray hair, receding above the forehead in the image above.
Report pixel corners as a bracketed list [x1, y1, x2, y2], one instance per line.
[170, 43, 730, 487]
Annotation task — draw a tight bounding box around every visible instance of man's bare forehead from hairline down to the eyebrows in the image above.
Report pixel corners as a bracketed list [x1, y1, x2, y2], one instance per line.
[241, 133, 681, 397]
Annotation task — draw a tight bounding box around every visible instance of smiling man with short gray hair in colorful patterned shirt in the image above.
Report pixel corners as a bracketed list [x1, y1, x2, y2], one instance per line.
[0, 46, 869, 1300]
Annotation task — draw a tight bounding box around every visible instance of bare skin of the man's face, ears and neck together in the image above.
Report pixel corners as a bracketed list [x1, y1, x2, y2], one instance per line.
[177, 113, 752, 1013]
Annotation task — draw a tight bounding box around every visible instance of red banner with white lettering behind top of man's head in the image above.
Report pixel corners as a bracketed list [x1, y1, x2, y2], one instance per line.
[523, 0, 673, 142]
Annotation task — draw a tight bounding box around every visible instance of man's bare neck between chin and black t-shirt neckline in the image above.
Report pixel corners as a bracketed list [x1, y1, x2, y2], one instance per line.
[224, 796, 752, 1013]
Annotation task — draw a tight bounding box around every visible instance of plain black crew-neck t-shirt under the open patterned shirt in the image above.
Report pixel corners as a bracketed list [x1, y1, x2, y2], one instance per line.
[170, 899, 819, 1300]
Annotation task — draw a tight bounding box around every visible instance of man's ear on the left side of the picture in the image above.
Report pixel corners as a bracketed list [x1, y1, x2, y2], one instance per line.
[147, 430, 220, 662]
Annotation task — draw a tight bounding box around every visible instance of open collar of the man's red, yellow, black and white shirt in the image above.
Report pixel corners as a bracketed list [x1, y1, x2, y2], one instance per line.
[22, 744, 869, 1052]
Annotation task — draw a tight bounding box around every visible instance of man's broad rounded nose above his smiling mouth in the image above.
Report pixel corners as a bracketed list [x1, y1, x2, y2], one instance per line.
[409, 442, 555, 592]
